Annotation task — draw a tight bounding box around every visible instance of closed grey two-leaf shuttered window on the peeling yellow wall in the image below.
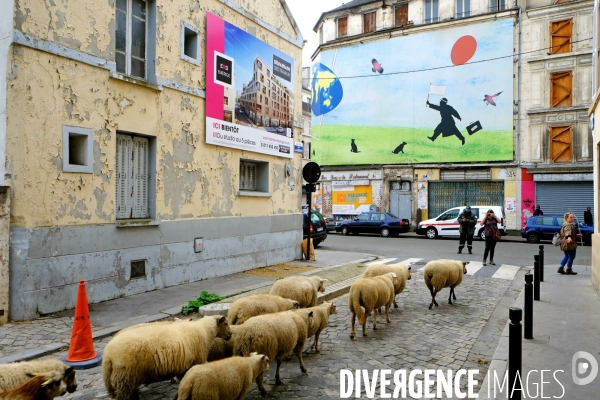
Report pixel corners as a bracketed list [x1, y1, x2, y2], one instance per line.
[116, 134, 150, 219]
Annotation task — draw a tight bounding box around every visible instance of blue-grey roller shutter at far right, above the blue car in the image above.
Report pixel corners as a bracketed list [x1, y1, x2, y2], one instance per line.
[535, 182, 594, 221]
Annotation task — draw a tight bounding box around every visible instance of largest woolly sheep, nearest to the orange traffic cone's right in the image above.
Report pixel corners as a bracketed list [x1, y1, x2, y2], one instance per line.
[102, 315, 231, 400]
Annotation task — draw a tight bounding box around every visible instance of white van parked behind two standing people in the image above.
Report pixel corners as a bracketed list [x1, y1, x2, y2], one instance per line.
[416, 206, 506, 240]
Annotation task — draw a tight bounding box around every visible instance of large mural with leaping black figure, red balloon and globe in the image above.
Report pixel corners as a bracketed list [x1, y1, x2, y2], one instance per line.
[311, 19, 514, 165]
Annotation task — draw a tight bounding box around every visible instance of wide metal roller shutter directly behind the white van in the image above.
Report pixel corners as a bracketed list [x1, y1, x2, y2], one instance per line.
[428, 181, 504, 218]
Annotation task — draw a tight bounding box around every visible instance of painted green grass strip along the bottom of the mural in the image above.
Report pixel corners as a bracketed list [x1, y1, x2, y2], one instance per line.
[312, 125, 513, 165]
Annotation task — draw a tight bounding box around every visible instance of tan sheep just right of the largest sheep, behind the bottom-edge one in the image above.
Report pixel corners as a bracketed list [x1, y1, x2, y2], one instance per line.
[233, 310, 313, 395]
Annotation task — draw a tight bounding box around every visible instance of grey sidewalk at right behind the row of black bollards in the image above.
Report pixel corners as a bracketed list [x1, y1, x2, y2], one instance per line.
[479, 260, 600, 399]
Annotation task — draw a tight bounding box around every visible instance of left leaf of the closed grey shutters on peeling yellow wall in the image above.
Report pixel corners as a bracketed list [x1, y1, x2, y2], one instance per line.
[117, 135, 133, 219]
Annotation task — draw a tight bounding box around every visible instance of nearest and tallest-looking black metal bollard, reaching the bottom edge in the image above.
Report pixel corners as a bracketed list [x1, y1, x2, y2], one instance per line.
[508, 307, 523, 400]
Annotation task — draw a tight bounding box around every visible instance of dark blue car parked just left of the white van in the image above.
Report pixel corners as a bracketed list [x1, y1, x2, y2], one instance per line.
[335, 212, 410, 237]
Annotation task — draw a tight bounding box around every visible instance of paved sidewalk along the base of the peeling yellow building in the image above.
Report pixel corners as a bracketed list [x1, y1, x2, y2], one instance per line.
[0, 249, 377, 364]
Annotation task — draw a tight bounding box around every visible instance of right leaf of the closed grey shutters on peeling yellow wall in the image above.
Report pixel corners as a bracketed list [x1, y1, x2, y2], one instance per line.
[132, 137, 148, 218]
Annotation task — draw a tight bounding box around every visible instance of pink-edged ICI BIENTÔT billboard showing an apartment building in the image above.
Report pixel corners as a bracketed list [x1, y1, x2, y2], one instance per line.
[206, 13, 294, 158]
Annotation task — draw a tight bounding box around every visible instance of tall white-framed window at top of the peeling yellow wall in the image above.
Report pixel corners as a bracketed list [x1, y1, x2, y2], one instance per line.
[115, 0, 147, 79]
